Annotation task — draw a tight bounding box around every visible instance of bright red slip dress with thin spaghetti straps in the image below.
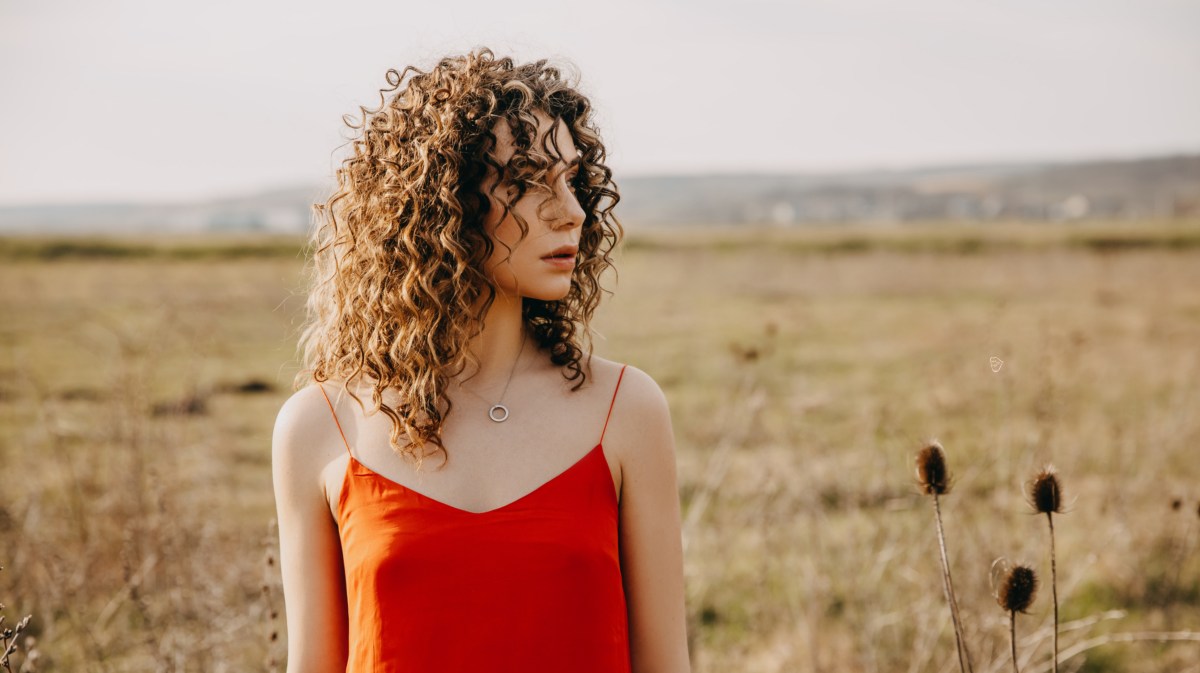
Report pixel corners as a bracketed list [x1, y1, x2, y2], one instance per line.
[322, 367, 630, 673]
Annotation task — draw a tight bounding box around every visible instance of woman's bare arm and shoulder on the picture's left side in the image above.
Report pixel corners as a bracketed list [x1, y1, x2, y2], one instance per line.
[271, 385, 347, 673]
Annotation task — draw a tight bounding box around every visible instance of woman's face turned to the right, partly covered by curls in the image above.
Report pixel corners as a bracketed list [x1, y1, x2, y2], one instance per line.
[482, 112, 584, 301]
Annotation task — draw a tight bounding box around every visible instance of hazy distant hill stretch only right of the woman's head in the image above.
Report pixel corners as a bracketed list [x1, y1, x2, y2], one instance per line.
[619, 155, 1200, 224]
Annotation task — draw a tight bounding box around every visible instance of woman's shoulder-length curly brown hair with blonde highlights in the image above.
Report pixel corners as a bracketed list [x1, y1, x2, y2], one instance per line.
[298, 48, 623, 467]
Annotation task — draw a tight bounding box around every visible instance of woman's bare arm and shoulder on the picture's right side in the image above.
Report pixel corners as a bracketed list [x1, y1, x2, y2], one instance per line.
[610, 367, 690, 673]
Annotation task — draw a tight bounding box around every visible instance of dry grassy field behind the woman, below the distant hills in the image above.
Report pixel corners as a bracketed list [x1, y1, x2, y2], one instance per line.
[0, 222, 1200, 673]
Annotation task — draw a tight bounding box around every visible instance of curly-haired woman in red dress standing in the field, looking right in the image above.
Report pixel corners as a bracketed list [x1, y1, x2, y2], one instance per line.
[272, 49, 689, 673]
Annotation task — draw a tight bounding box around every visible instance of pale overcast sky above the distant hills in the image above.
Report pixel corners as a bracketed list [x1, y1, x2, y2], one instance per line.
[0, 0, 1200, 206]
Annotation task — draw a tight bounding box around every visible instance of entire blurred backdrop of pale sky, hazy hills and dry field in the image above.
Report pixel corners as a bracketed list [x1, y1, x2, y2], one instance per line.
[0, 0, 1200, 672]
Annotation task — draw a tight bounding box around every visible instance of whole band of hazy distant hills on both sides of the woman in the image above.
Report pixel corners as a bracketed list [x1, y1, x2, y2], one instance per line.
[0, 155, 1200, 234]
